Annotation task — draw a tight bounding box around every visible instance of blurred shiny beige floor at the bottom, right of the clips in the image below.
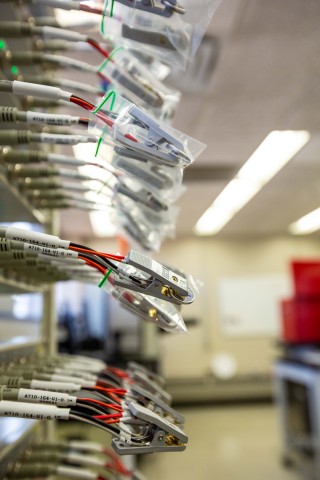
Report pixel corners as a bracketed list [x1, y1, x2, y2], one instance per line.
[140, 404, 299, 480]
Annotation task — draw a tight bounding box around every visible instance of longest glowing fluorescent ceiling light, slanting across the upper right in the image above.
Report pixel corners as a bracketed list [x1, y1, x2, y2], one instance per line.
[194, 130, 310, 235]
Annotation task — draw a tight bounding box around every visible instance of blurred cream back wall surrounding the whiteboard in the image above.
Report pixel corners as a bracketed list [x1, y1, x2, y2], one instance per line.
[152, 237, 320, 378]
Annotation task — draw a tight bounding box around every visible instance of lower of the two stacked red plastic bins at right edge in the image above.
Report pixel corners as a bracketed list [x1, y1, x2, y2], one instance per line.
[281, 299, 320, 344]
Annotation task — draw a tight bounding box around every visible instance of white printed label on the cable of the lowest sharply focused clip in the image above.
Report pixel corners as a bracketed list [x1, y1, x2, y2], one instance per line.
[0, 400, 70, 420]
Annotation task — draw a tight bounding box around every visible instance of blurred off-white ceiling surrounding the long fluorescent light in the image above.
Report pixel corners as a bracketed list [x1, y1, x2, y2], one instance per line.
[61, 0, 320, 240]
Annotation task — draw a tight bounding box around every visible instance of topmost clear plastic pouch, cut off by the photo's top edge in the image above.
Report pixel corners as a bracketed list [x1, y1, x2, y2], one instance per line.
[101, 0, 221, 69]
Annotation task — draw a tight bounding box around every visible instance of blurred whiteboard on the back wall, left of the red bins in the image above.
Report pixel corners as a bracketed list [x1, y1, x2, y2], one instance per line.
[217, 274, 291, 337]
